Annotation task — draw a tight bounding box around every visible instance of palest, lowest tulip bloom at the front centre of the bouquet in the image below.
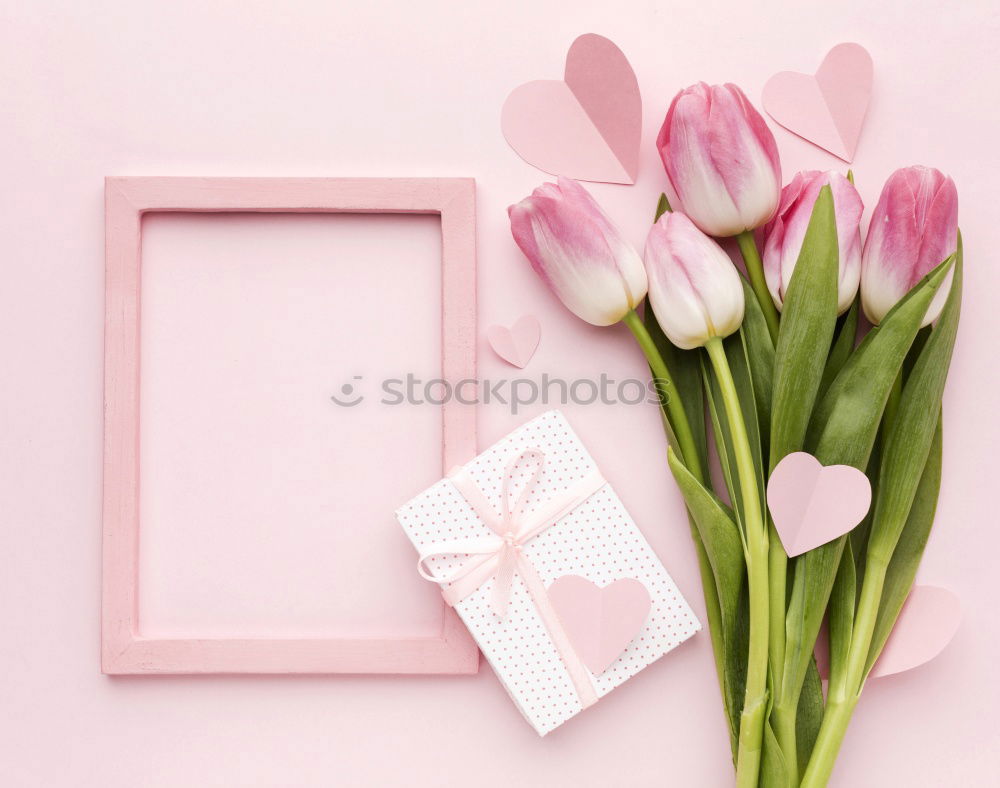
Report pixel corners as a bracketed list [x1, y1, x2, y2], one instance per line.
[645, 213, 743, 350]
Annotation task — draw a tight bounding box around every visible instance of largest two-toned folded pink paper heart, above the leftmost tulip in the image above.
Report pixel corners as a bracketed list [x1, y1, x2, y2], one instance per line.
[500, 33, 642, 183]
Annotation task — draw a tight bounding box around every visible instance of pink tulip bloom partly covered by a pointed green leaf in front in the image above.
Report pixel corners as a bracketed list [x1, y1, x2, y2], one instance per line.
[764, 171, 864, 314]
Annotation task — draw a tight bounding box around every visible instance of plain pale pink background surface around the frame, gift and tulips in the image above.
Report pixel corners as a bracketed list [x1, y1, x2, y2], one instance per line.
[0, 0, 1000, 788]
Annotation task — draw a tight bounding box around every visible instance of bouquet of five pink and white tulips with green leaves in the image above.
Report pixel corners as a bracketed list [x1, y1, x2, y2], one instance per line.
[509, 84, 962, 787]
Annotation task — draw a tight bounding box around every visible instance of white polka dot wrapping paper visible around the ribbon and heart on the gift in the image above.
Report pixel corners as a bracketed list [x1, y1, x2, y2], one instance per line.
[396, 410, 701, 736]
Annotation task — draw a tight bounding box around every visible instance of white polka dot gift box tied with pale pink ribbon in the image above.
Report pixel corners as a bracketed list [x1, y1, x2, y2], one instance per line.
[396, 410, 701, 736]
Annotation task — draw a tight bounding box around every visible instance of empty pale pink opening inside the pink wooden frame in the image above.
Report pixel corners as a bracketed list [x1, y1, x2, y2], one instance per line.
[138, 213, 441, 638]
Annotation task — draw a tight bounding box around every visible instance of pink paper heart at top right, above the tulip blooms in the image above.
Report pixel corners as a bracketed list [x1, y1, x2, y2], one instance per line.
[762, 44, 873, 162]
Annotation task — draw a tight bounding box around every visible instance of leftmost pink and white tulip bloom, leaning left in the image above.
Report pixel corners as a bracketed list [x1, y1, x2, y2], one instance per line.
[507, 178, 646, 326]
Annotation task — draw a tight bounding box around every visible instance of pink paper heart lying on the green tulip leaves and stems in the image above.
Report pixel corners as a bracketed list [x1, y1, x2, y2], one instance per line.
[767, 451, 872, 556]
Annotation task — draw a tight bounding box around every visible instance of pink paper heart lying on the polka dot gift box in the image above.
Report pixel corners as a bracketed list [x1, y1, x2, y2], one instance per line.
[549, 575, 651, 676]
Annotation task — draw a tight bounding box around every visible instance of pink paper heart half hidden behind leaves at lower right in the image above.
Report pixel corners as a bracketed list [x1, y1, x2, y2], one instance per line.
[871, 586, 962, 677]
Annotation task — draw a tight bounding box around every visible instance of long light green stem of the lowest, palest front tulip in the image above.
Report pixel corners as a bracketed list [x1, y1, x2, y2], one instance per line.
[705, 337, 769, 788]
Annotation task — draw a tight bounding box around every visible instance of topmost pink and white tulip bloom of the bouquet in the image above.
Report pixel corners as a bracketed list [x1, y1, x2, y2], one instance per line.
[656, 82, 781, 237]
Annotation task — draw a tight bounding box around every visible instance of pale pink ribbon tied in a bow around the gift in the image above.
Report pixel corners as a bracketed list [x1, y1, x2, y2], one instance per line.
[417, 449, 605, 708]
